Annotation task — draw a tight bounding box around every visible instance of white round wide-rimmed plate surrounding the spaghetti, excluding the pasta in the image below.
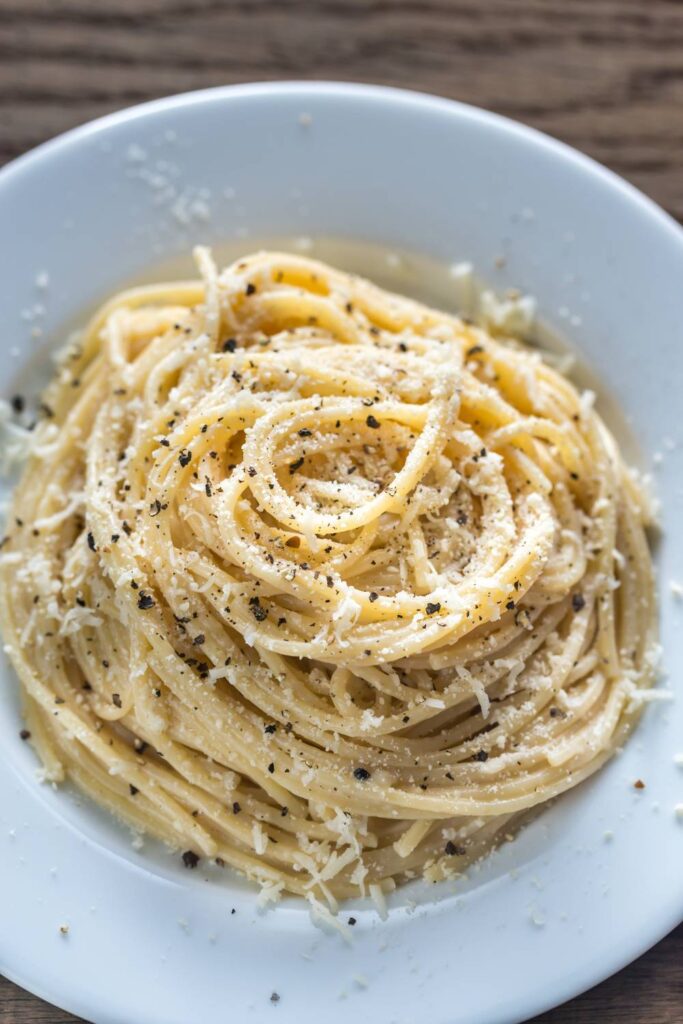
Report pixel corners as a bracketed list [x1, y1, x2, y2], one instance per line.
[0, 83, 683, 1024]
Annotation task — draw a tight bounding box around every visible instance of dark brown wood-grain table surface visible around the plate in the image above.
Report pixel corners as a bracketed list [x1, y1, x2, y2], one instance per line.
[0, 0, 683, 1024]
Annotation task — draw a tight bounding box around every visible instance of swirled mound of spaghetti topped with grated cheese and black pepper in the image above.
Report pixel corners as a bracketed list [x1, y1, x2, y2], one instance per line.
[0, 250, 655, 910]
